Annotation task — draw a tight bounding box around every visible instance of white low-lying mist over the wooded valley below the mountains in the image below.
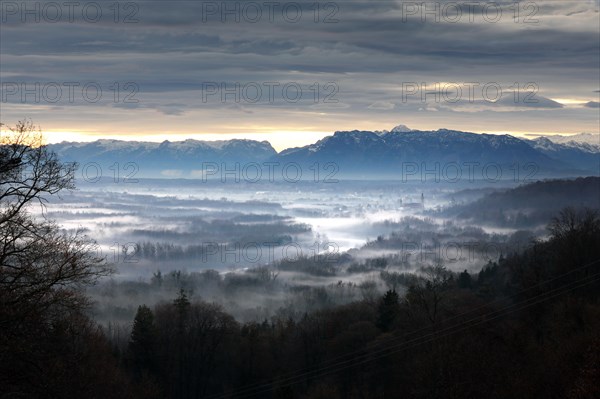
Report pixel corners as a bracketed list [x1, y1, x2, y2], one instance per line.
[37, 180, 596, 337]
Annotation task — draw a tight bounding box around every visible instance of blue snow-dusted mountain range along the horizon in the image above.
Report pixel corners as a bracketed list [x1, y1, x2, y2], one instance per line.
[49, 125, 600, 178]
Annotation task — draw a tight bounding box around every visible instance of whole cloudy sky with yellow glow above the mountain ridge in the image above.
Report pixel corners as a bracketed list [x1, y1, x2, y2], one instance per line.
[0, 0, 600, 150]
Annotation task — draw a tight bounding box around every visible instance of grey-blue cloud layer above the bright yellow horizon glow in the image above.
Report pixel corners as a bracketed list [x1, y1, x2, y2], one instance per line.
[0, 0, 600, 142]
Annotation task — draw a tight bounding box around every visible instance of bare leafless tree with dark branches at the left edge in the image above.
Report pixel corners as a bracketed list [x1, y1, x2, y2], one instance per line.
[0, 121, 111, 332]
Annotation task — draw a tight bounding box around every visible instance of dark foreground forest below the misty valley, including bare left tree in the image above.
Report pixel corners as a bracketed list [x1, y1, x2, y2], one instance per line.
[0, 122, 600, 399]
